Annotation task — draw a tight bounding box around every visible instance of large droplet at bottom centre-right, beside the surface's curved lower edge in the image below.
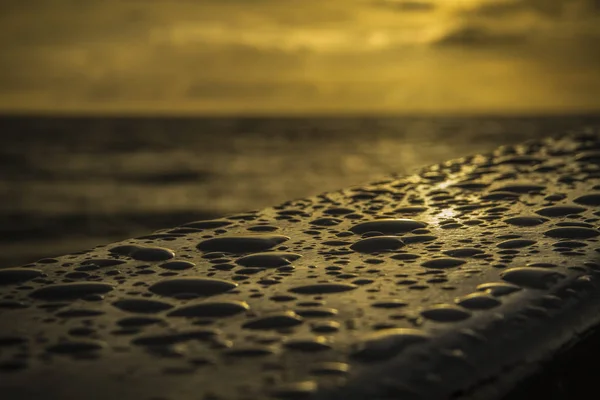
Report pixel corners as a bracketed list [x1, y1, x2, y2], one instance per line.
[351, 328, 430, 361]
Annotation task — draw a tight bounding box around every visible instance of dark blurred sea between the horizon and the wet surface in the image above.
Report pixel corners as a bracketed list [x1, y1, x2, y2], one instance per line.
[0, 115, 600, 267]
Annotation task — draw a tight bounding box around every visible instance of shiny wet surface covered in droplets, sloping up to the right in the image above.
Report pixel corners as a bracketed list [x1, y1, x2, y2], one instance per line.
[0, 130, 600, 399]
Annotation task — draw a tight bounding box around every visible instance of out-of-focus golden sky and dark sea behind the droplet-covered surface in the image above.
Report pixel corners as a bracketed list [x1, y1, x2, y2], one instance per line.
[0, 0, 600, 267]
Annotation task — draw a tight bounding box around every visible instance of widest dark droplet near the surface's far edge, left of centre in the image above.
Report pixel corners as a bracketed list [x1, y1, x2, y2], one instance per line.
[196, 235, 290, 254]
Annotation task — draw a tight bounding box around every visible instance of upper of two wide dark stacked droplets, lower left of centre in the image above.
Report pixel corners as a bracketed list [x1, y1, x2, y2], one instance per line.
[149, 277, 237, 296]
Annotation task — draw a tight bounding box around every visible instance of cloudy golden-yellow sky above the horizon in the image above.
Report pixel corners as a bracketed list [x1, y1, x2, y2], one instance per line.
[0, 0, 600, 115]
